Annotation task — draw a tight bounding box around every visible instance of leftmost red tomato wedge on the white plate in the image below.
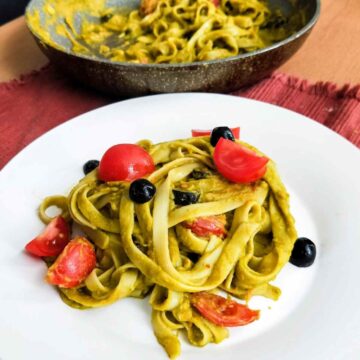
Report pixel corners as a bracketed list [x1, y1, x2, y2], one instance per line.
[25, 216, 70, 256]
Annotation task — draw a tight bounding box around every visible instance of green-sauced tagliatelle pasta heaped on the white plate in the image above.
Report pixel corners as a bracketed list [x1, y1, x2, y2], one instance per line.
[34, 136, 297, 359]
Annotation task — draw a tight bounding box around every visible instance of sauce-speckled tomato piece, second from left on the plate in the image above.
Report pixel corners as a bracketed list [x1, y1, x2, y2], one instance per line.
[46, 236, 96, 288]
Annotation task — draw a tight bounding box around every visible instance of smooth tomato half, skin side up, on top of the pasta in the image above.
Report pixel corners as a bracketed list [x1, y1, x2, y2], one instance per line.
[99, 144, 155, 181]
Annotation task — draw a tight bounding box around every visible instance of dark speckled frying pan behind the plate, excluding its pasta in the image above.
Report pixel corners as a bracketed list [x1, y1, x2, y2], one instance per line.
[27, 0, 320, 97]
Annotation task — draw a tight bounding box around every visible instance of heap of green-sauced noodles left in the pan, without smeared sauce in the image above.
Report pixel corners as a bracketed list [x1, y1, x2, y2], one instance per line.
[74, 0, 300, 63]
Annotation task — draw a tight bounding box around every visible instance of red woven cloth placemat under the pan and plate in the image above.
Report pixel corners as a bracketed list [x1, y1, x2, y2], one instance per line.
[0, 66, 360, 169]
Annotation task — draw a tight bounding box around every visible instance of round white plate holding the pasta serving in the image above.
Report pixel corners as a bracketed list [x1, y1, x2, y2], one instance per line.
[0, 94, 360, 360]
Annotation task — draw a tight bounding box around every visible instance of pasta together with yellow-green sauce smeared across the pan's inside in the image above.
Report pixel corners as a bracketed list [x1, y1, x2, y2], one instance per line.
[27, 0, 305, 64]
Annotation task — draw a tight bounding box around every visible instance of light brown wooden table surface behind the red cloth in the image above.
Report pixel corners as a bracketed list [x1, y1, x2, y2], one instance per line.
[0, 0, 360, 85]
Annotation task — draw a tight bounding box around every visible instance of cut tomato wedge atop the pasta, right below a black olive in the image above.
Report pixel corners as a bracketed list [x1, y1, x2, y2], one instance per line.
[214, 138, 269, 183]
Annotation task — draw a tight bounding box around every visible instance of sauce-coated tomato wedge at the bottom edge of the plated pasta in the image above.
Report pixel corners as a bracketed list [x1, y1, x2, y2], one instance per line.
[190, 292, 260, 327]
